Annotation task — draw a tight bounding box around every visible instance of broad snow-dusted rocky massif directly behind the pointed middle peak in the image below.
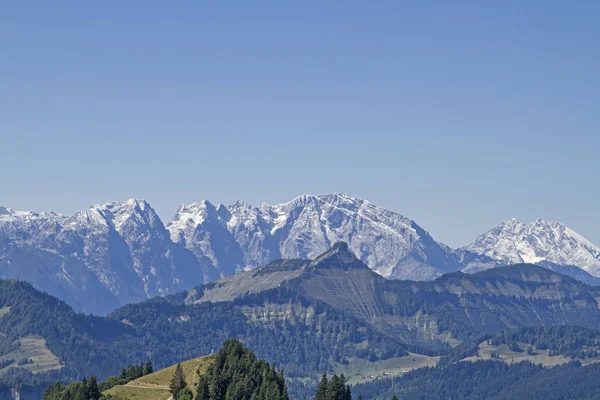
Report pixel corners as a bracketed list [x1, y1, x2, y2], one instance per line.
[167, 194, 494, 280]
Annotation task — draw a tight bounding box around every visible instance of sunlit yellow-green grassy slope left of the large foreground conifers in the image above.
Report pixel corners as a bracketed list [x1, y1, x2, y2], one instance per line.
[104, 356, 213, 400]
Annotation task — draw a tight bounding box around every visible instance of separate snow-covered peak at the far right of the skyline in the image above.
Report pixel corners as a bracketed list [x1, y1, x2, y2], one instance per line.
[465, 219, 600, 276]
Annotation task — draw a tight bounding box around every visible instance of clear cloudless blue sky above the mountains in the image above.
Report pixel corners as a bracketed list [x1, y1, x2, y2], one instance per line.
[0, 0, 600, 246]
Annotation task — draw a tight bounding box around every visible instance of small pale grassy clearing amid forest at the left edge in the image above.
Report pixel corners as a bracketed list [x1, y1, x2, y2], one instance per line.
[0, 336, 63, 375]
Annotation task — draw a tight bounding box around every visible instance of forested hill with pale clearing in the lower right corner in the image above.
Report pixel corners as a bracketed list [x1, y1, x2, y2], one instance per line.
[353, 326, 600, 400]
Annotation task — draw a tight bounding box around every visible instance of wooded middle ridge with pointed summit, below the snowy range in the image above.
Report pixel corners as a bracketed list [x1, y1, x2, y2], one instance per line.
[0, 243, 600, 394]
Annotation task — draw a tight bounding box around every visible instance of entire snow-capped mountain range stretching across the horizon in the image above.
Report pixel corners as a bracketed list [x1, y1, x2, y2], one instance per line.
[0, 194, 600, 313]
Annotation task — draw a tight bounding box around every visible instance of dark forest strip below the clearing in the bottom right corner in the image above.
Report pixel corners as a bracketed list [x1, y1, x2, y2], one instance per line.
[353, 360, 600, 400]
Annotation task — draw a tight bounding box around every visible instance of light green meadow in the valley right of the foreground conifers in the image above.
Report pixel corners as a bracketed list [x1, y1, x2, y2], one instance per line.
[335, 353, 440, 384]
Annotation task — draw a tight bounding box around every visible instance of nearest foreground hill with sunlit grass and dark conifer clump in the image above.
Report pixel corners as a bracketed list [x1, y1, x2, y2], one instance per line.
[44, 339, 289, 400]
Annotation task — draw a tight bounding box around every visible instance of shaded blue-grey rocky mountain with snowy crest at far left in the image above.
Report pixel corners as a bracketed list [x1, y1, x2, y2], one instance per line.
[0, 199, 204, 314]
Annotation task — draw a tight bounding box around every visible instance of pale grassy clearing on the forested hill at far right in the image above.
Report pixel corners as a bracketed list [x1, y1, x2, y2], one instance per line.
[461, 342, 600, 367]
